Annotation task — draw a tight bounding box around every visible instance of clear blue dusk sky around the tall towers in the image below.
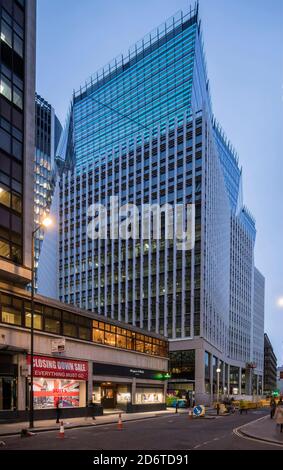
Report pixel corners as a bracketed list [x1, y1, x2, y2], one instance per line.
[37, 0, 283, 365]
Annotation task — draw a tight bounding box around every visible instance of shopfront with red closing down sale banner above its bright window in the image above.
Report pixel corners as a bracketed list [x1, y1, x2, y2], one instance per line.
[27, 356, 88, 409]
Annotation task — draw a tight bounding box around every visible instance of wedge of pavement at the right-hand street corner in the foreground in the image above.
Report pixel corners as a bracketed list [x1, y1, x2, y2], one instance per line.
[235, 415, 283, 449]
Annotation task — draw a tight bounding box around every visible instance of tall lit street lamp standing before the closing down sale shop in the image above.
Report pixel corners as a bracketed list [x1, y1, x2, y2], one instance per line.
[29, 217, 52, 428]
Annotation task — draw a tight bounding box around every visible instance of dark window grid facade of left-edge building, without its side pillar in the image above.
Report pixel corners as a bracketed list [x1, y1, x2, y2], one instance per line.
[0, 0, 25, 264]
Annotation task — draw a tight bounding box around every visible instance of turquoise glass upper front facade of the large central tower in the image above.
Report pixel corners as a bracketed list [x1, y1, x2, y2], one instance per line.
[73, 10, 198, 167]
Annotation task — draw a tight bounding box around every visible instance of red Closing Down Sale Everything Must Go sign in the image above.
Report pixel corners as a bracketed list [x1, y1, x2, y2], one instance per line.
[27, 355, 88, 380]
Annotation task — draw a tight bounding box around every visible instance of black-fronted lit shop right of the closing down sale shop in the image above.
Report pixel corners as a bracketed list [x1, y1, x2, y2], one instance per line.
[92, 363, 166, 411]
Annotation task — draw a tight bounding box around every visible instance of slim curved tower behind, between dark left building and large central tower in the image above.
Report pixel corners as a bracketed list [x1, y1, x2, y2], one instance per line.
[34, 94, 62, 289]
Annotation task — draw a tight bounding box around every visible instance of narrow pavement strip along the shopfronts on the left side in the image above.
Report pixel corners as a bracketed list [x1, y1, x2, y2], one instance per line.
[0, 408, 220, 437]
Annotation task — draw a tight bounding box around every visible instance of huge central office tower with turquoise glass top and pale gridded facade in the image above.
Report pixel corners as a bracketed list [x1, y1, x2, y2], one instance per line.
[41, 6, 264, 401]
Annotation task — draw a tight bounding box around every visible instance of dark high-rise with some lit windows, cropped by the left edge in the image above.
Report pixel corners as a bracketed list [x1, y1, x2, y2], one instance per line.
[0, 0, 35, 284]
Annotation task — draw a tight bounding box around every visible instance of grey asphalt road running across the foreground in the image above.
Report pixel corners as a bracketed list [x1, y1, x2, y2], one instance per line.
[1, 411, 282, 451]
